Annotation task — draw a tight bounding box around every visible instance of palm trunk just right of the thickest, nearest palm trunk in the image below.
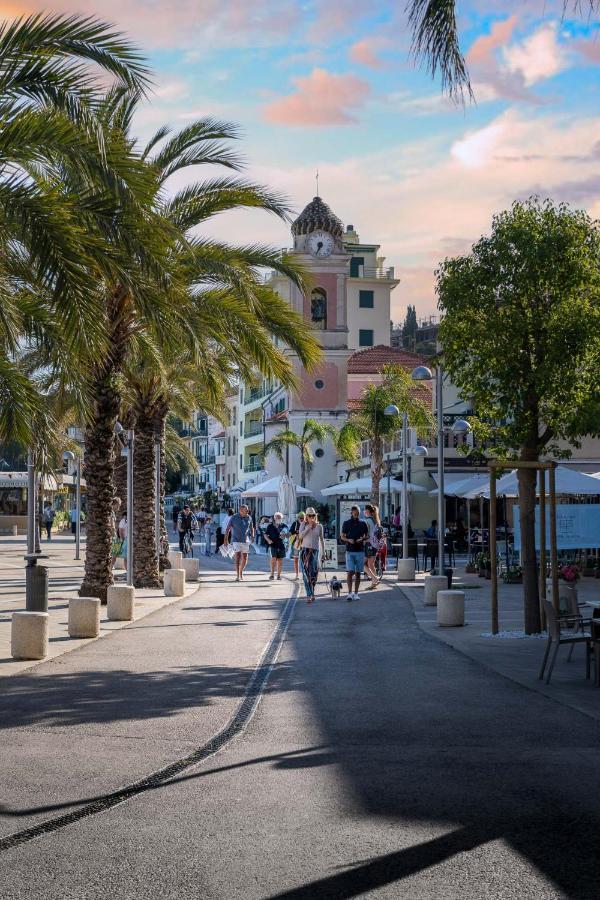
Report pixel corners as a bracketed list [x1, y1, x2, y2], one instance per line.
[133, 415, 161, 588]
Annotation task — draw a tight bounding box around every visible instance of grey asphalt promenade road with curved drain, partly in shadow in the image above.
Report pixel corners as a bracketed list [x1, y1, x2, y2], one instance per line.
[0, 564, 600, 900]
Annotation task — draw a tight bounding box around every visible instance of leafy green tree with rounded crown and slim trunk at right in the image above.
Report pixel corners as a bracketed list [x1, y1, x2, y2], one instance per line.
[437, 198, 600, 634]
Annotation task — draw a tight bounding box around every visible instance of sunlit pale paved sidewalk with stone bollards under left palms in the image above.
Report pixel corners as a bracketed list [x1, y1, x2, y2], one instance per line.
[0, 535, 198, 678]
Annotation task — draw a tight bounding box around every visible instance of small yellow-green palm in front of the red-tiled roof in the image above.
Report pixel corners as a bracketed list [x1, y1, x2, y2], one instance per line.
[337, 365, 435, 503]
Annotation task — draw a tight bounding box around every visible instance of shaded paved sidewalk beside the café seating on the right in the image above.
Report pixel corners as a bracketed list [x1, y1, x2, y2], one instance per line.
[398, 567, 600, 720]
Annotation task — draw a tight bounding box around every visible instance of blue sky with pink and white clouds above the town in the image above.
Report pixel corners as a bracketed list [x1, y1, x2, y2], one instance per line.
[0, 0, 600, 320]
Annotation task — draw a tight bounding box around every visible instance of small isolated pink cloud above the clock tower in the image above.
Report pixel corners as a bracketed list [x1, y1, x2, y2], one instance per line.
[264, 69, 371, 128]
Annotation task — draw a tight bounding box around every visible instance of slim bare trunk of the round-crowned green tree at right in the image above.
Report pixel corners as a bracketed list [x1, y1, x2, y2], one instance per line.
[517, 458, 542, 634]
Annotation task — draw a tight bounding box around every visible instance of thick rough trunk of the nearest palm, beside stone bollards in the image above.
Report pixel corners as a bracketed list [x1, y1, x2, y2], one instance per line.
[79, 373, 120, 603]
